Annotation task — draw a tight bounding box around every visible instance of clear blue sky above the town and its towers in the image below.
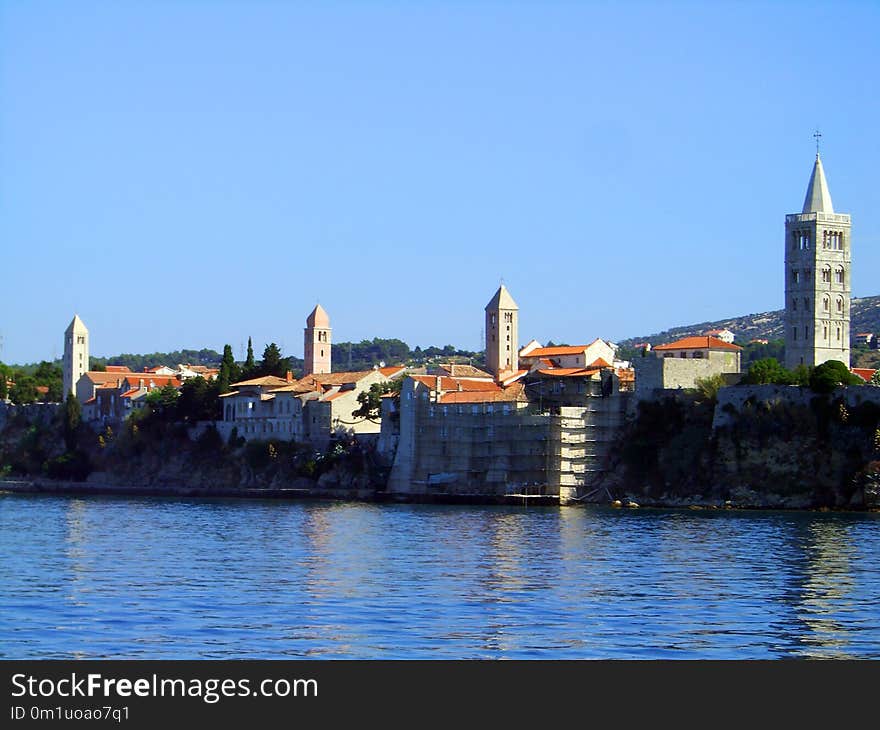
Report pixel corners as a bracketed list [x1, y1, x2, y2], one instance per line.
[0, 0, 880, 363]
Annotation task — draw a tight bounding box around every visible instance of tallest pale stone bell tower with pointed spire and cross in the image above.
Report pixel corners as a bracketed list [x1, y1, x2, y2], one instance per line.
[785, 152, 851, 368]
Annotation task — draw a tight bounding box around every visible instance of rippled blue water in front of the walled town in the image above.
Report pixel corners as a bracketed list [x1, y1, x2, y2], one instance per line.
[0, 496, 880, 659]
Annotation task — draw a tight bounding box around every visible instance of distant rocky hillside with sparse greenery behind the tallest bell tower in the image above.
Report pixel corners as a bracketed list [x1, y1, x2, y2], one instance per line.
[618, 296, 880, 347]
